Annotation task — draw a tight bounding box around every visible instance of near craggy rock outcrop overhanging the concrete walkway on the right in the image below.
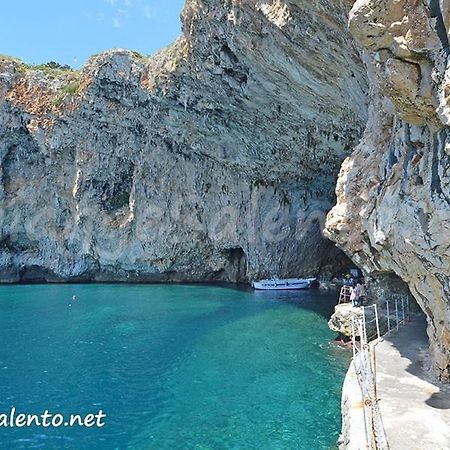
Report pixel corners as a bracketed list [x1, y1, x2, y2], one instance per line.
[326, 0, 450, 380]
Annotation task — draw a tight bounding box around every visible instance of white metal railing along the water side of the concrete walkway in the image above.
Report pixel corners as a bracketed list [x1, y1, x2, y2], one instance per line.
[352, 297, 410, 450]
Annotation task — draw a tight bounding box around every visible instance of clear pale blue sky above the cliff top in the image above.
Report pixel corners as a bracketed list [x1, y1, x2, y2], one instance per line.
[0, 0, 184, 68]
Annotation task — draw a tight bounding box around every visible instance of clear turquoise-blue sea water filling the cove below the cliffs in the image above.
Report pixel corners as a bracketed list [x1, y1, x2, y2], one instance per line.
[0, 285, 348, 450]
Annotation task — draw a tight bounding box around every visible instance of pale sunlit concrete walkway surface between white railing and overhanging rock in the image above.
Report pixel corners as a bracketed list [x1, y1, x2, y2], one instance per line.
[375, 318, 450, 450]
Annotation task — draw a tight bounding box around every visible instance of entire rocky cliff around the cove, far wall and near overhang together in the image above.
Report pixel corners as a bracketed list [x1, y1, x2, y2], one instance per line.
[0, 0, 450, 446]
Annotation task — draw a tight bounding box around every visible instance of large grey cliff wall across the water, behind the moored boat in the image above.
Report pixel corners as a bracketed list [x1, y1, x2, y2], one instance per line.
[0, 0, 368, 281]
